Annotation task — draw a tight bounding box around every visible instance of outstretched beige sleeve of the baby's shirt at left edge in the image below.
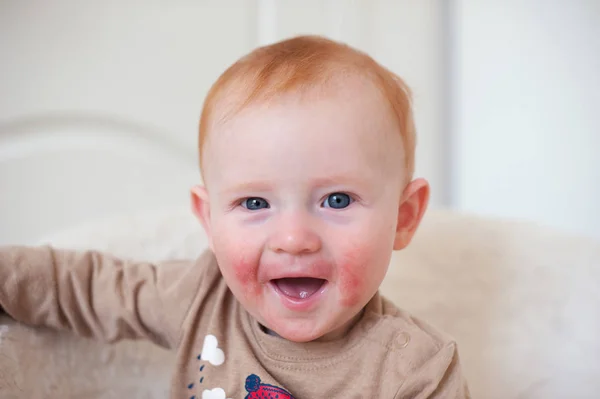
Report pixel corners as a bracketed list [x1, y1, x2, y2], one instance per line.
[0, 246, 206, 348]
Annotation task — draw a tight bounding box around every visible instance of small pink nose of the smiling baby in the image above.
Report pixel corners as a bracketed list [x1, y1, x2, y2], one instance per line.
[269, 213, 321, 255]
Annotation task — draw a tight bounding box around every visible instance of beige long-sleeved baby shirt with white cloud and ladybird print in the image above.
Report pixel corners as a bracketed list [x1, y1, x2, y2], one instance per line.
[0, 247, 470, 399]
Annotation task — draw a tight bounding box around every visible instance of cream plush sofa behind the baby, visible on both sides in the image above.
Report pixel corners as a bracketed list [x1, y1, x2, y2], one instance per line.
[0, 210, 600, 399]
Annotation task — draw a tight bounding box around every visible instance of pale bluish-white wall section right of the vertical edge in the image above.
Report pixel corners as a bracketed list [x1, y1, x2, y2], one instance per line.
[450, 0, 600, 238]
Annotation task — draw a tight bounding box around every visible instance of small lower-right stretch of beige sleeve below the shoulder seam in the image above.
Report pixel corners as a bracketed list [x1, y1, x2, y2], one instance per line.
[394, 342, 471, 399]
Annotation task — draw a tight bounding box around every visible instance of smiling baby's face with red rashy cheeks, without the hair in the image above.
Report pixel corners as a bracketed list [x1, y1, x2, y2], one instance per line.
[196, 76, 424, 342]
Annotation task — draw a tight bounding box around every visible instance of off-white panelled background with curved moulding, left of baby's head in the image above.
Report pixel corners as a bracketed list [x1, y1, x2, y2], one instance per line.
[0, 0, 255, 244]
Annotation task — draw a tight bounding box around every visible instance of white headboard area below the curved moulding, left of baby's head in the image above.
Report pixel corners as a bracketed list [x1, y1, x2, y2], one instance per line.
[0, 114, 200, 245]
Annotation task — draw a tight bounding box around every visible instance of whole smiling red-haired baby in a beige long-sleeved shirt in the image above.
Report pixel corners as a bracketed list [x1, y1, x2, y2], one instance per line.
[0, 36, 469, 399]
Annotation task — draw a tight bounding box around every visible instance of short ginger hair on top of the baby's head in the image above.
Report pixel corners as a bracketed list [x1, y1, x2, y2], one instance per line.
[198, 36, 416, 179]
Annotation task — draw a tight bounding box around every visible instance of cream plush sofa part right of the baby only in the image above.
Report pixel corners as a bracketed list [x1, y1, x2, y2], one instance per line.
[382, 212, 600, 399]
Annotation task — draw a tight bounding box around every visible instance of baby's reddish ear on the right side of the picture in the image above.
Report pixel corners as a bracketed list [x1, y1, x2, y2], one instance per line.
[394, 179, 429, 250]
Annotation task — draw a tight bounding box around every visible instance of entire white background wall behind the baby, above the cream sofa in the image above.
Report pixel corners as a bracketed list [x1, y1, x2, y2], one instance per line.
[0, 0, 600, 241]
